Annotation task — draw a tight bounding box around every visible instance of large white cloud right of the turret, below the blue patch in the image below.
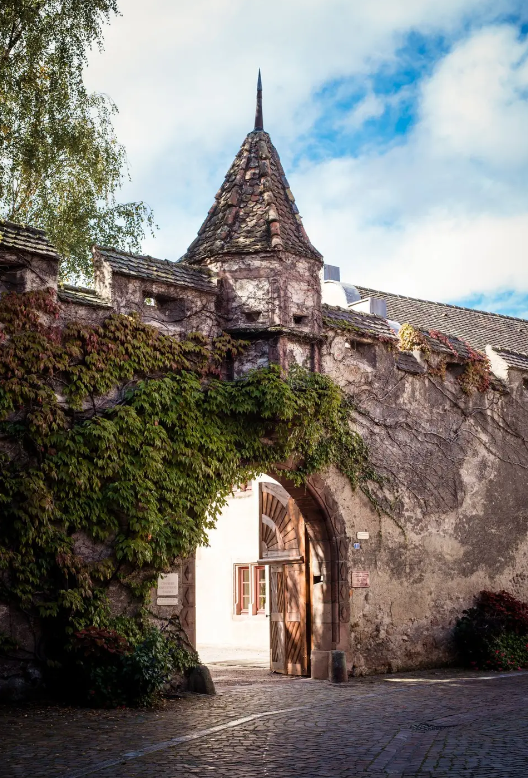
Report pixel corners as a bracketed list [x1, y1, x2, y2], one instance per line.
[293, 26, 528, 300]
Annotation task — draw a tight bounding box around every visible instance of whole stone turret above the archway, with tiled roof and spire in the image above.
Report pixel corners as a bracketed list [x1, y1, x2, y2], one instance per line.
[181, 72, 323, 370]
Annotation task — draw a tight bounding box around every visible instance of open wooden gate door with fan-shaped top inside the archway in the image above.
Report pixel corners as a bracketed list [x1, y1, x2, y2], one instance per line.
[259, 483, 310, 675]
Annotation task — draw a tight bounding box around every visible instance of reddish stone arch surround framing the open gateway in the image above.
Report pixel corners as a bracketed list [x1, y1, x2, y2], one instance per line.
[180, 469, 350, 678]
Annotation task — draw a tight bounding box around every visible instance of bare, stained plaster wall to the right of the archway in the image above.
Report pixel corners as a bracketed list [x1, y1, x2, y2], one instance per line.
[323, 333, 528, 673]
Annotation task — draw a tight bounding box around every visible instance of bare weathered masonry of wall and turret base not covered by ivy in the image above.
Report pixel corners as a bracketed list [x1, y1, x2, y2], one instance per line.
[0, 235, 528, 683]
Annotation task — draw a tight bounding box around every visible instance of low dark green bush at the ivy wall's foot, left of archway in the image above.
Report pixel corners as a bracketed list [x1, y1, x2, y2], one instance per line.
[71, 627, 198, 708]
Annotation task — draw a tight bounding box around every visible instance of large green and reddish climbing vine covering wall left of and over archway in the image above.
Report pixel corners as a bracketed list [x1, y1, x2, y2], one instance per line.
[0, 290, 379, 664]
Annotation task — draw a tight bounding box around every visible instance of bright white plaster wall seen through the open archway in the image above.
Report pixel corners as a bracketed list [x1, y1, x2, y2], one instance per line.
[196, 476, 276, 650]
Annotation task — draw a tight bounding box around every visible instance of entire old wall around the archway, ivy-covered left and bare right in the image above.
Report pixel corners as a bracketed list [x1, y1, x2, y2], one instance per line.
[0, 233, 528, 683]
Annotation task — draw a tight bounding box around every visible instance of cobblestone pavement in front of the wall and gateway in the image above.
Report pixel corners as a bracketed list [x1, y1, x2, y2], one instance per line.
[0, 666, 528, 778]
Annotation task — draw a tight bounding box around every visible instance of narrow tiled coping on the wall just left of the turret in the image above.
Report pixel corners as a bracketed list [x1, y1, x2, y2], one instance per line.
[94, 246, 217, 294]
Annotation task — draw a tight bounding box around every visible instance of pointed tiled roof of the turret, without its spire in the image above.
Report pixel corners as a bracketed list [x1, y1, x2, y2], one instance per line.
[182, 130, 321, 262]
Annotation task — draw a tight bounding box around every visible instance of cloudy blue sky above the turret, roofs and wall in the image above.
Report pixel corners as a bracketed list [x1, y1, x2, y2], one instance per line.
[87, 0, 528, 317]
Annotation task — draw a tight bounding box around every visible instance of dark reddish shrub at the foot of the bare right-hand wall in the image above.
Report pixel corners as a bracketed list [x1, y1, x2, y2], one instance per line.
[455, 591, 528, 670]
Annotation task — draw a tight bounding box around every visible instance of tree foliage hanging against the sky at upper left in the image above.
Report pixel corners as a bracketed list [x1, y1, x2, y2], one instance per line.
[0, 0, 153, 276]
